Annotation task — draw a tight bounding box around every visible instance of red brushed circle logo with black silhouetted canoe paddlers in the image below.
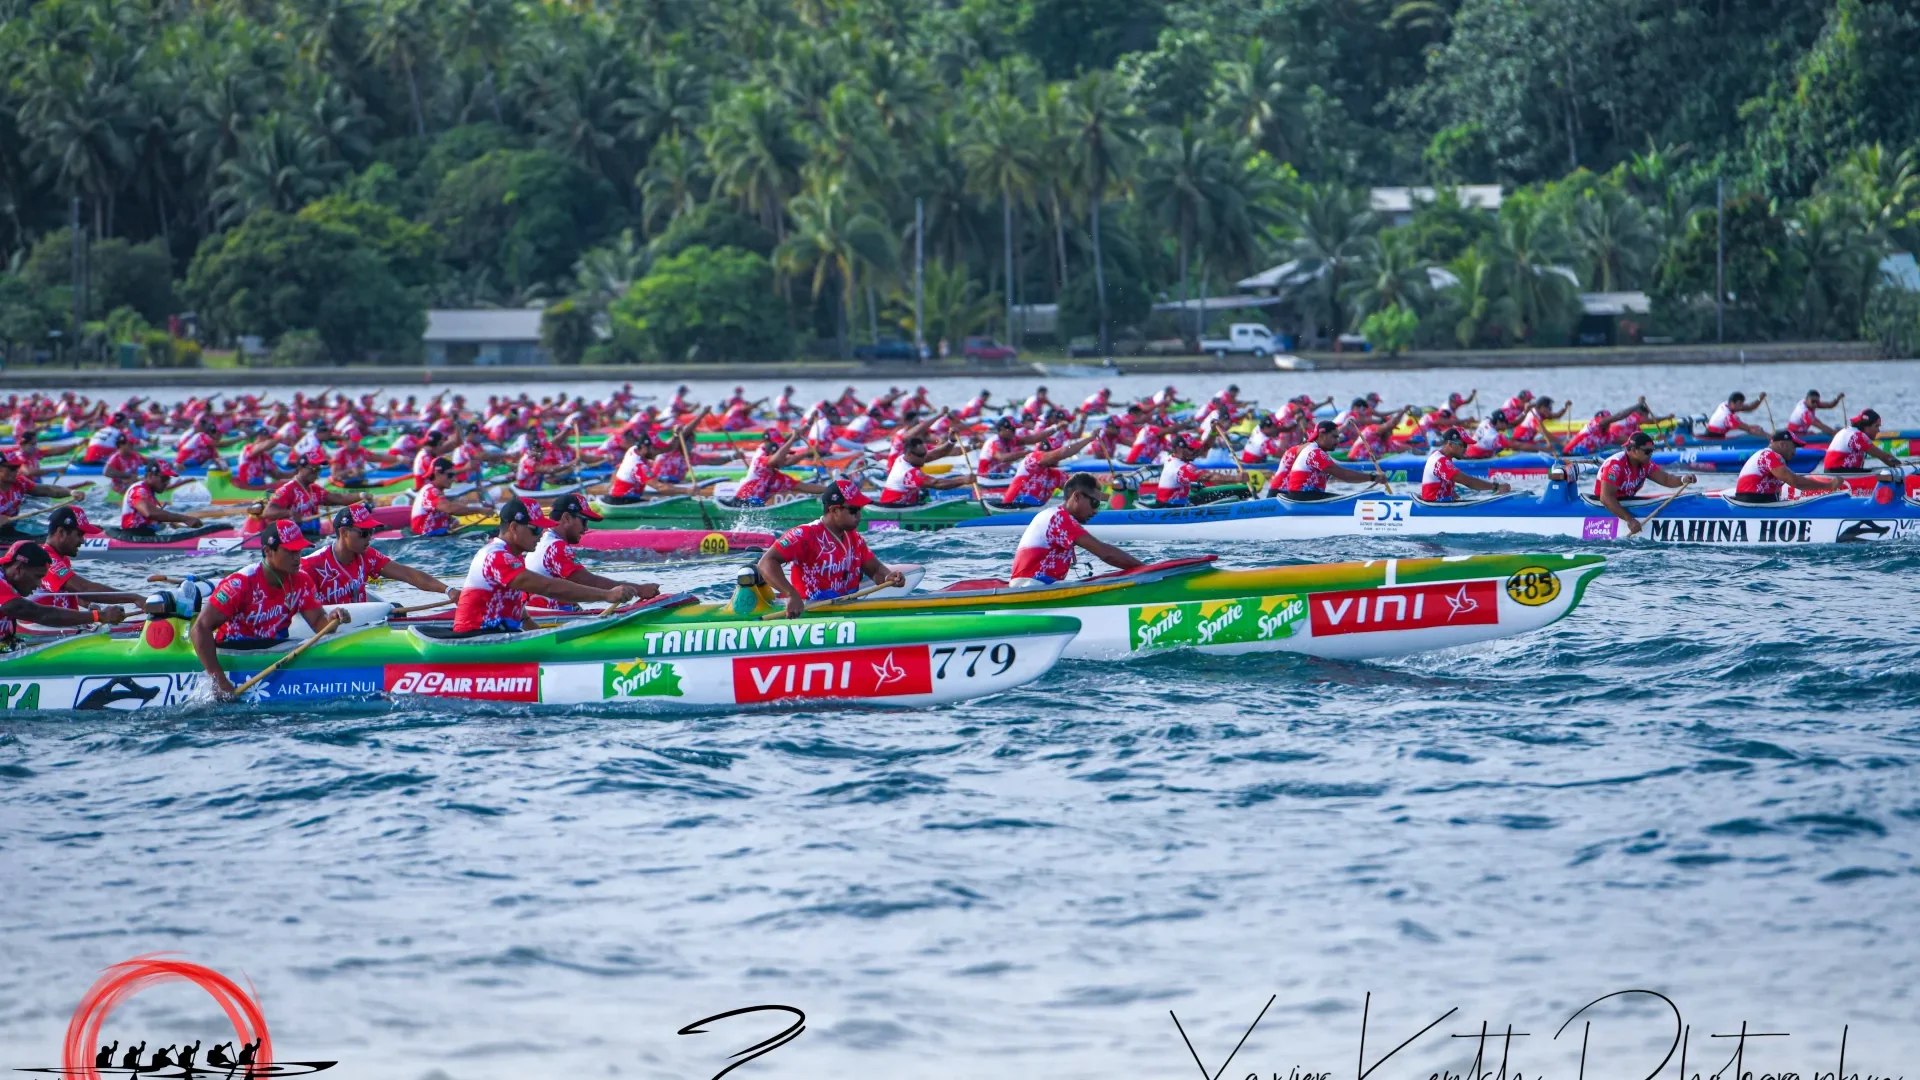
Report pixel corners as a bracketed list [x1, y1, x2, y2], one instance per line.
[15, 953, 338, 1080]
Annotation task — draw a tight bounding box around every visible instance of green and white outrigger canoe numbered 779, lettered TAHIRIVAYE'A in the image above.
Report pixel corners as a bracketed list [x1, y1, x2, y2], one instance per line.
[0, 594, 1079, 711]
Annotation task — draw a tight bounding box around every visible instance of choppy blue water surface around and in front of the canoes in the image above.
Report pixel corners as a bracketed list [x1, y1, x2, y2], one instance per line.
[0, 365, 1920, 1080]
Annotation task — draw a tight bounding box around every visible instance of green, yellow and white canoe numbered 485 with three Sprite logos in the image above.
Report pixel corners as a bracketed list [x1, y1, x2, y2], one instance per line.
[698, 555, 1605, 671]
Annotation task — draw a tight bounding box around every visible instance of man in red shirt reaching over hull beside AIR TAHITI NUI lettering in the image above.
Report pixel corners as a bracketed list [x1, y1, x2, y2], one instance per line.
[188, 519, 349, 701]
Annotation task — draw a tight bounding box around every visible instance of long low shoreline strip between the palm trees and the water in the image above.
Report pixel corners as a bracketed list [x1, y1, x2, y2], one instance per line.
[0, 342, 1901, 390]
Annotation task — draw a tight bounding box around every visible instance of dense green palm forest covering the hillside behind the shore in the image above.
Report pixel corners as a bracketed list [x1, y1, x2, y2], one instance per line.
[0, 0, 1920, 359]
